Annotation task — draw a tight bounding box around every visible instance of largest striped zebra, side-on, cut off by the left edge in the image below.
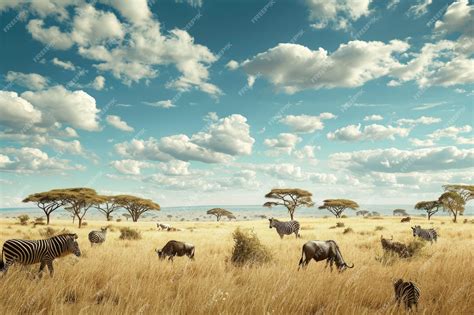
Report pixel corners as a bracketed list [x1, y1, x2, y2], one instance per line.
[0, 234, 81, 276]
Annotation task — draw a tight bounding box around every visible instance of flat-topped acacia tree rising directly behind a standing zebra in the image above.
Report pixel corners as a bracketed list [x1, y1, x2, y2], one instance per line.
[263, 188, 314, 220]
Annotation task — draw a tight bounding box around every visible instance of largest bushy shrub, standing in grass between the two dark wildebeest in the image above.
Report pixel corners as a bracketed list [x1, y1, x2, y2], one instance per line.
[230, 228, 272, 266]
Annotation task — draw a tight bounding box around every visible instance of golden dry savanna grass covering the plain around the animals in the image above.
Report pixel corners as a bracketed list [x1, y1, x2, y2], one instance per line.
[0, 217, 474, 314]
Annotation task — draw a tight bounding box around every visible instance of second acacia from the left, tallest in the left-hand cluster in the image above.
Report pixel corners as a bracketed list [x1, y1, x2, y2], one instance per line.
[52, 187, 105, 228]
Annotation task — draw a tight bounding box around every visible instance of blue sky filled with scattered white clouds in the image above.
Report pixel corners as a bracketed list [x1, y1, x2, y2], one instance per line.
[0, 0, 474, 207]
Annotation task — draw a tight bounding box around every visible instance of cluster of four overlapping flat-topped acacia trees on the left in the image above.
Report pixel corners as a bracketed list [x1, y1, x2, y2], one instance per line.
[23, 187, 160, 228]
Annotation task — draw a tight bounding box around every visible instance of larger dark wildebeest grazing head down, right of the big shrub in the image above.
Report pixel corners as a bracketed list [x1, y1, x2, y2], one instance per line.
[298, 240, 354, 272]
